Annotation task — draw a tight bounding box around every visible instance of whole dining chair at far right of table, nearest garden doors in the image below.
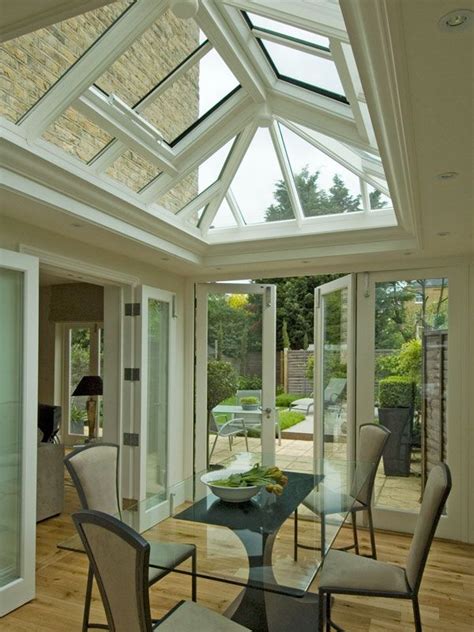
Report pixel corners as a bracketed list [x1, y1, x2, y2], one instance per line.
[293, 424, 390, 560]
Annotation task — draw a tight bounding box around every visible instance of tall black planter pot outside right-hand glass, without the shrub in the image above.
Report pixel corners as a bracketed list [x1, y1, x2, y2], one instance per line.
[379, 408, 413, 476]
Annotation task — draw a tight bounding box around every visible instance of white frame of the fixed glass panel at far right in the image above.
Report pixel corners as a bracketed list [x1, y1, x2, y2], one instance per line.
[357, 266, 472, 541]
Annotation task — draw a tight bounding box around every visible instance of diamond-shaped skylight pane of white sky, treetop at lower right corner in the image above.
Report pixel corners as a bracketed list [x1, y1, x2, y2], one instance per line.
[230, 127, 294, 224]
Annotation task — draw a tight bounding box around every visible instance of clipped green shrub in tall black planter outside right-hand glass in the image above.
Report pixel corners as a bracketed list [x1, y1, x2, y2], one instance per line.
[378, 375, 415, 476]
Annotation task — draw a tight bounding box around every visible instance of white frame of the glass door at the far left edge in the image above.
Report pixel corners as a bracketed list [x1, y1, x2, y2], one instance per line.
[0, 249, 39, 616]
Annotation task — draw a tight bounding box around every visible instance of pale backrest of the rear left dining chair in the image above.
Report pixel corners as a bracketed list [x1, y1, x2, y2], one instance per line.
[64, 443, 120, 514]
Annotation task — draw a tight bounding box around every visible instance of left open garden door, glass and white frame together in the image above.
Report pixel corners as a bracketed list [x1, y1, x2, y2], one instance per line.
[196, 283, 280, 468]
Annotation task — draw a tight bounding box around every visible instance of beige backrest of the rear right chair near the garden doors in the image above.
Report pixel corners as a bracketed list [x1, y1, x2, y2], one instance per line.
[353, 424, 390, 505]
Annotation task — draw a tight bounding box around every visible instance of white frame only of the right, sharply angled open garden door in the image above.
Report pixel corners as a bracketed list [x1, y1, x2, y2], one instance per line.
[313, 274, 357, 461]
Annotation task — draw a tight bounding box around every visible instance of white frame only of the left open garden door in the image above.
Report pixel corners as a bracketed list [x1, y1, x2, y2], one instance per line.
[194, 283, 276, 471]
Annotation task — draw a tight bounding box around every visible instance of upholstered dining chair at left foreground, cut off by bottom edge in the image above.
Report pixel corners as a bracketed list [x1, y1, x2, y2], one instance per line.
[72, 510, 248, 632]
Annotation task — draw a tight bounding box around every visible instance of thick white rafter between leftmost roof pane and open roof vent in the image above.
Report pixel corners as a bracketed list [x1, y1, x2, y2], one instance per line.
[20, 0, 168, 141]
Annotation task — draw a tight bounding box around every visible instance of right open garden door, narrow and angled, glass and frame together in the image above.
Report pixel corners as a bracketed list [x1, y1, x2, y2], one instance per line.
[314, 275, 355, 459]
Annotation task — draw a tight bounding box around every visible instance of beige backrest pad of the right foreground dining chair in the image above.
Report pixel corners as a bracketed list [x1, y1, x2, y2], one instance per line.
[406, 463, 451, 592]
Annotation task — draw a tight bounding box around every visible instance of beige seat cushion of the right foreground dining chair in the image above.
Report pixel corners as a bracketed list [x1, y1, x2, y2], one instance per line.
[319, 549, 409, 595]
